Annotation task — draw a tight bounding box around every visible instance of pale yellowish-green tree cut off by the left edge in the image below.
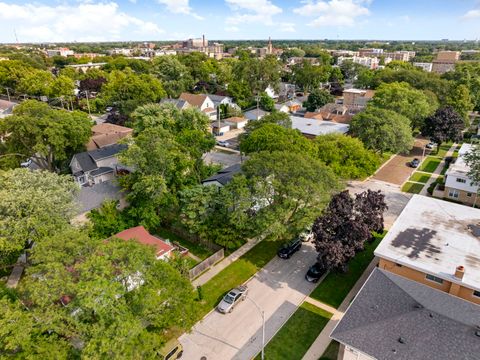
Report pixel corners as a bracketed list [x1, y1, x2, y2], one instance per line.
[0, 169, 77, 263]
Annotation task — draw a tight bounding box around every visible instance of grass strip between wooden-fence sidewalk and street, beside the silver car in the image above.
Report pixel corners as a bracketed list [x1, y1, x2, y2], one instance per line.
[199, 238, 282, 317]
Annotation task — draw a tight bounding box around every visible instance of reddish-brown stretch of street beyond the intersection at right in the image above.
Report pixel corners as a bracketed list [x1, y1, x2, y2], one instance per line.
[374, 139, 429, 185]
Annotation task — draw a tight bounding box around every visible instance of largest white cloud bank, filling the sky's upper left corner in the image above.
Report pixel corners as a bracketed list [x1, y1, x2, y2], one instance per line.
[0, 2, 163, 42]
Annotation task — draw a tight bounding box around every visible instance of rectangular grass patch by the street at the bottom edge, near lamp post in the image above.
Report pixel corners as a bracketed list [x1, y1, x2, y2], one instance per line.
[255, 302, 332, 360]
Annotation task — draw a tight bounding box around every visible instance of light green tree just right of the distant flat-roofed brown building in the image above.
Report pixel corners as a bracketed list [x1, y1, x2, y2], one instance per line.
[369, 82, 438, 129]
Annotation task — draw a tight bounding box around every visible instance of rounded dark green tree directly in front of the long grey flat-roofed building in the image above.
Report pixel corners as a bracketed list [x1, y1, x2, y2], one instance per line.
[240, 123, 316, 156]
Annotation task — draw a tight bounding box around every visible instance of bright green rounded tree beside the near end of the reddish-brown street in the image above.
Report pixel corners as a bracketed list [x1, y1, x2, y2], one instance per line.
[315, 134, 379, 179]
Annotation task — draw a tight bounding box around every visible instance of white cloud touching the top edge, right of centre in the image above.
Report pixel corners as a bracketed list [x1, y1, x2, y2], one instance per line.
[293, 0, 371, 27]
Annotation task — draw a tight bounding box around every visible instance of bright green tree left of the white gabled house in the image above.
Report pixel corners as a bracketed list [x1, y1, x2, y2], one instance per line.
[101, 70, 166, 115]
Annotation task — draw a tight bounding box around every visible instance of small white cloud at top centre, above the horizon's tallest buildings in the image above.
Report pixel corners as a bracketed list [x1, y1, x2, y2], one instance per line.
[225, 0, 282, 25]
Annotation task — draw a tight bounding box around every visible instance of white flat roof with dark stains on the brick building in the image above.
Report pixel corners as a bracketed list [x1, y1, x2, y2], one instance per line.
[375, 195, 480, 291]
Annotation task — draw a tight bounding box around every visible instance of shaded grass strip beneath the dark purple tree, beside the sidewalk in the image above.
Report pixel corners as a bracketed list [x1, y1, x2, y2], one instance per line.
[310, 234, 384, 308]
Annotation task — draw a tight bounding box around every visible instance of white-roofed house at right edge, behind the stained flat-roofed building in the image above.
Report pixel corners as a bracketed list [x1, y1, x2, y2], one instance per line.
[443, 144, 478, 205]
